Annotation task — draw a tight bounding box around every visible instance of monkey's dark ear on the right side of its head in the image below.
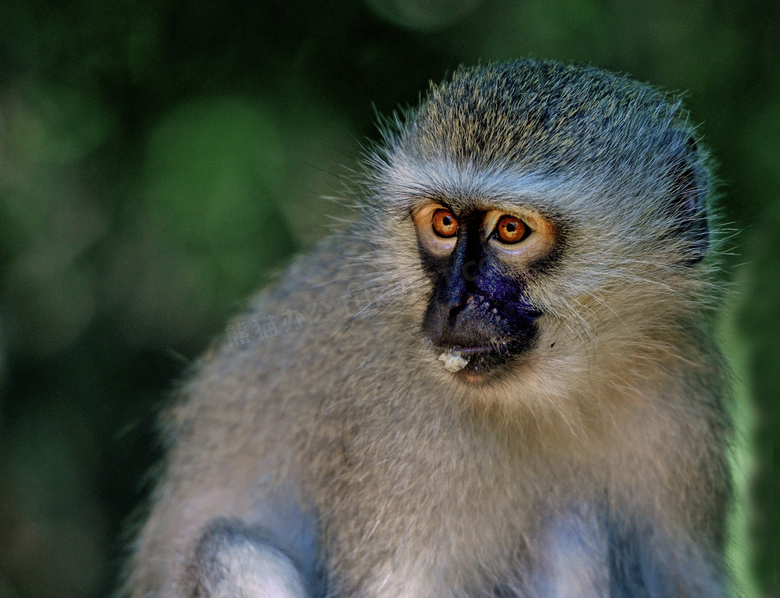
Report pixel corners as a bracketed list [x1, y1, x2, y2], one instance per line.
[670, 131, 710, 266]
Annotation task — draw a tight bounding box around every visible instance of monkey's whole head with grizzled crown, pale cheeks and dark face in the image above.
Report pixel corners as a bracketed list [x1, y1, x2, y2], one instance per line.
[369, 61, 709, 390]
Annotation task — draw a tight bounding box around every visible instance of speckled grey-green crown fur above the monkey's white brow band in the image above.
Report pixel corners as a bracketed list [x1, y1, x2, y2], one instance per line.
[399, 60, 692, 174]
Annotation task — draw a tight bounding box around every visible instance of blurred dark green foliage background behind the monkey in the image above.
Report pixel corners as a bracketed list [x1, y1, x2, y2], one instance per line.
[0, 0, 780, 598]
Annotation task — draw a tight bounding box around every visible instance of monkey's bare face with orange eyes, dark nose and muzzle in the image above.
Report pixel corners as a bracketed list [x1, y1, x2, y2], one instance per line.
[412, 202, 556, 381]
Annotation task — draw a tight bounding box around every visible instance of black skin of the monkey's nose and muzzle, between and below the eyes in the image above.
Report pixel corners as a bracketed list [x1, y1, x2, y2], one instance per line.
[420, 212, 541, 375]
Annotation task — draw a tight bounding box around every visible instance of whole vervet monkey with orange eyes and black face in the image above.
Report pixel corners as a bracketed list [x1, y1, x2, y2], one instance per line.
[127, 60, 730, 598]
